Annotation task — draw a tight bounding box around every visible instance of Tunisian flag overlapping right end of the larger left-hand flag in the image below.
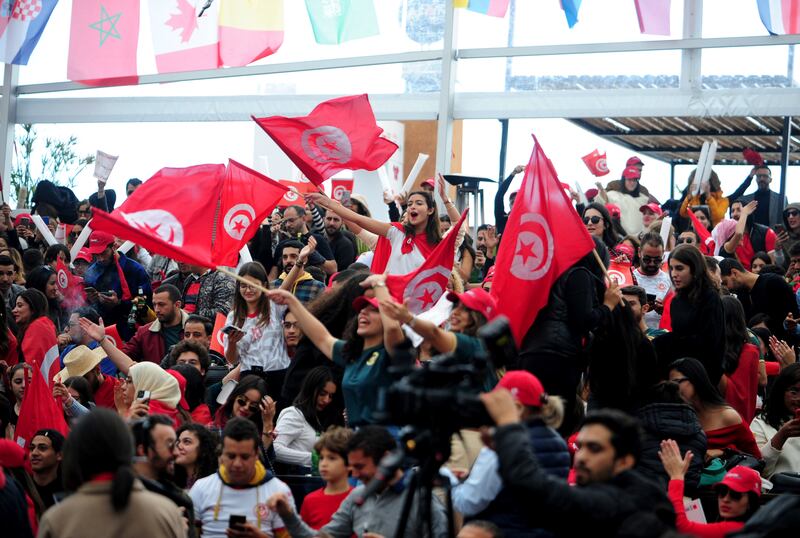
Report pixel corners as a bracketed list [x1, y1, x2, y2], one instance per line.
[212, 159, 288, 267]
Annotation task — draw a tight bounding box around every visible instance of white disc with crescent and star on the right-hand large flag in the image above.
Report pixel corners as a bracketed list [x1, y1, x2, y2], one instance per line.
[511, 213, 554, 280]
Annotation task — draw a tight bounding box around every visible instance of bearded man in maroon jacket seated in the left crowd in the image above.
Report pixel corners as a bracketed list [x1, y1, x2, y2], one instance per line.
[122, 284, 189, 364]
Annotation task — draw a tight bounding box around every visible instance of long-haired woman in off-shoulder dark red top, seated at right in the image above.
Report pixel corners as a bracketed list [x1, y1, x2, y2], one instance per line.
[669, 358, 761, 460]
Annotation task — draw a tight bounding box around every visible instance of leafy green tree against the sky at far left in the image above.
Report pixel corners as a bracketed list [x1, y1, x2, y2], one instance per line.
[11, 123, 94, 207]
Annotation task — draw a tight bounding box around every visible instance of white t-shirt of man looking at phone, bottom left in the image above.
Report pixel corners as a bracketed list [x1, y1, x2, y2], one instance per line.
[189, 473, 294, 538]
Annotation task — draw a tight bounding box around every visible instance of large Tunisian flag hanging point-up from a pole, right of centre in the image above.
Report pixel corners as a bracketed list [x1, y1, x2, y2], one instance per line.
[492, 136, 594, 346]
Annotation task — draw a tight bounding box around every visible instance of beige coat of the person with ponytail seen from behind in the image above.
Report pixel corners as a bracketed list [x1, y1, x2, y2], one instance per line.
[38, 480, 186, 538]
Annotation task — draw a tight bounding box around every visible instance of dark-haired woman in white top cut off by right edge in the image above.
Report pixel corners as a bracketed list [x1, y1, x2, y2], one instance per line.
[750, 363, 800, 478]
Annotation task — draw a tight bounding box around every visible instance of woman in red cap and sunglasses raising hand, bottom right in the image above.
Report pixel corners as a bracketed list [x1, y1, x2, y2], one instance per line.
[658, 439, 761, 538]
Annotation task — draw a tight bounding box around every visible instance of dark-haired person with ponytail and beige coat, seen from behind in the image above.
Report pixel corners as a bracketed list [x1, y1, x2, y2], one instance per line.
[39, 409, 186, 538]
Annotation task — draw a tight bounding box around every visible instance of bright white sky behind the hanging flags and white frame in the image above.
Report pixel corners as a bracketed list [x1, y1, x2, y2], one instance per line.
[7, 0, 800, 222]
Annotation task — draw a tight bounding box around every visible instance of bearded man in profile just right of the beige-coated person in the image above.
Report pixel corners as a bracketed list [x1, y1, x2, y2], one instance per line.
[131, 415, 197, 537]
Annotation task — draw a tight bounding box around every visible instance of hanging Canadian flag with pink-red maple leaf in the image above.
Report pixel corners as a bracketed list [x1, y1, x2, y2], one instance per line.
[149, 0, 219, 73]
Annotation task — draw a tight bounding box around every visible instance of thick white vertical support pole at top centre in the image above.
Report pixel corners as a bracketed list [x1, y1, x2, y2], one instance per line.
[436, 2, 457, 174]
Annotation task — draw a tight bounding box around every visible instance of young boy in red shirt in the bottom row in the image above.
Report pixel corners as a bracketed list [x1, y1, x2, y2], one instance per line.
[300, 428, 353, 529]
